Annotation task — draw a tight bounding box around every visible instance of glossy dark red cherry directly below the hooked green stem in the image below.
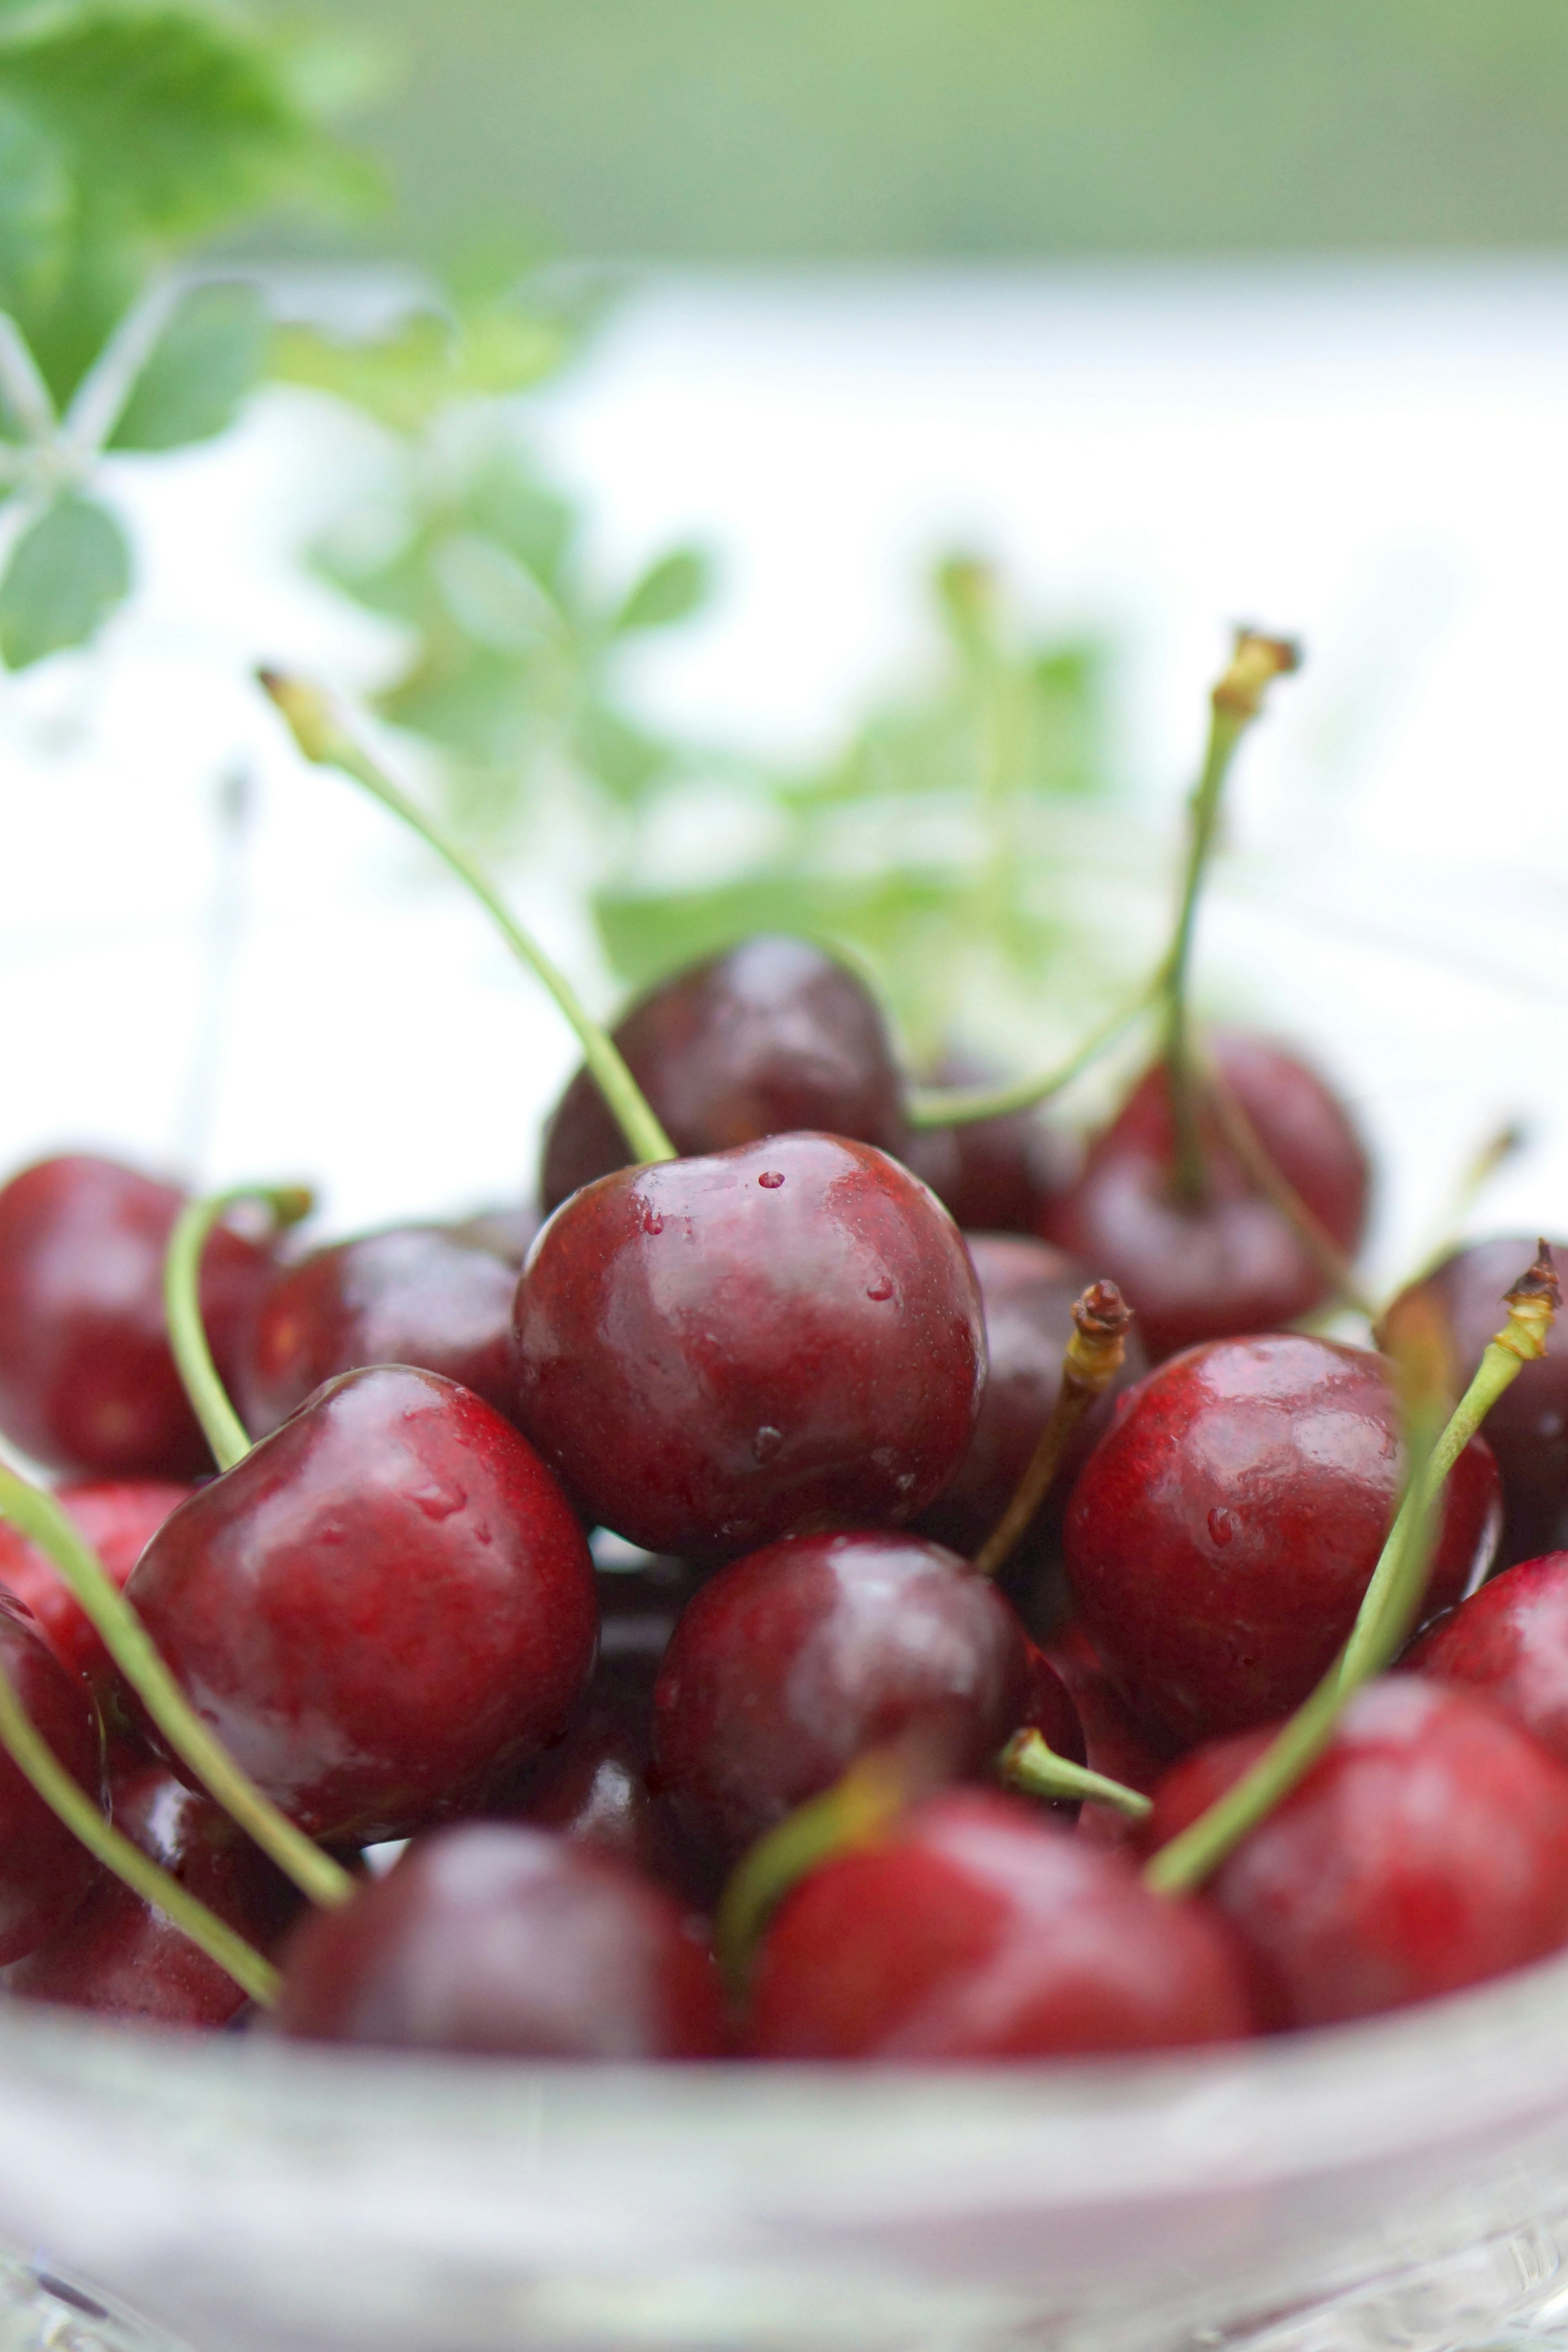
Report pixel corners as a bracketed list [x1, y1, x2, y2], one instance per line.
[127, 1364, 597, 1844]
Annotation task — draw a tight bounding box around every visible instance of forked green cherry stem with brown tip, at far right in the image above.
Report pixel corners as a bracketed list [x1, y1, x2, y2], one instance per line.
[1145, 1242, 1561, 1896]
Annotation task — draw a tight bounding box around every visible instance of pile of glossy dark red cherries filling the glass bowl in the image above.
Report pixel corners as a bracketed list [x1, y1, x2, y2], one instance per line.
[0, 795, 1568, 2060]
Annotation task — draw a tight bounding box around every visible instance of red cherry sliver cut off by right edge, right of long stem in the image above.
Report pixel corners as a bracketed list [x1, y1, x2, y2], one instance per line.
[1401, 1552, 1568, 1764]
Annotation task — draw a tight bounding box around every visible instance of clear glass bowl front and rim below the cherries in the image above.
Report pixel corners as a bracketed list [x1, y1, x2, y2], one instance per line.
[0, 1959, 1568, 2352]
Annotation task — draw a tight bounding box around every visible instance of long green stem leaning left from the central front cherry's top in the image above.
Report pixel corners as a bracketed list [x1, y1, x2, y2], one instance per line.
[256, 670, 677, 1164]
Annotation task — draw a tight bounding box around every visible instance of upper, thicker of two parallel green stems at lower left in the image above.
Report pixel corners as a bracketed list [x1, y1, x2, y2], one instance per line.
[0, 1468, 355, 1903]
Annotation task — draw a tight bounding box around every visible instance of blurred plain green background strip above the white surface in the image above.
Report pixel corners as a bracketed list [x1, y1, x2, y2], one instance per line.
[255, 0, 1568, 261]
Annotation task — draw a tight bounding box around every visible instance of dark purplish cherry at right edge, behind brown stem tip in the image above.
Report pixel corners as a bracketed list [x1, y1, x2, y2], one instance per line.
[1385, 1235, 1568, 1566]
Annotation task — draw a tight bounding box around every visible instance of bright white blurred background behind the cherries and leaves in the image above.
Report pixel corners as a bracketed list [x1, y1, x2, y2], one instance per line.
[0, 259, 1568, 1277]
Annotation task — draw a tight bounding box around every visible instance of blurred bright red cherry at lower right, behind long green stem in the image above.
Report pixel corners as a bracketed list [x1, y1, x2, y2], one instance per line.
[1140, 1675, 1568, 2025]
